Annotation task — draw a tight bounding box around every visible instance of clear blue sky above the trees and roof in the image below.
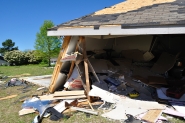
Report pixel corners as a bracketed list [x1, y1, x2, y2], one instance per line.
[0, 0, 124, 51]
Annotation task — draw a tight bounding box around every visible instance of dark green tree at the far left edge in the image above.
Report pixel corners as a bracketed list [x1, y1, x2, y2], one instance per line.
[0, 39, 18, 55]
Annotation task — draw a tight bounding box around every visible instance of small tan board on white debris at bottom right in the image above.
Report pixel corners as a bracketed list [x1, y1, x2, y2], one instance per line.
[141, 110, 162, 123]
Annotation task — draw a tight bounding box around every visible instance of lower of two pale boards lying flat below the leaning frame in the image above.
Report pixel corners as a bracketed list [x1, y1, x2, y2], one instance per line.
[38, 94, 86, 100]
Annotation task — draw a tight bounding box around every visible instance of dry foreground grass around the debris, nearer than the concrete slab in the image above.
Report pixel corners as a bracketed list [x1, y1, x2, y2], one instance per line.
[0, 85, 119, 123]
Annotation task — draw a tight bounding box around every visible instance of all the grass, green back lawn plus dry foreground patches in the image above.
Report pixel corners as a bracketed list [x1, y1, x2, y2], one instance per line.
[0, 65, 115, 123]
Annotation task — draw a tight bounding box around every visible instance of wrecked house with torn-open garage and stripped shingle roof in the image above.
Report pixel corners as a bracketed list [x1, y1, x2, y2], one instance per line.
[19, 0, 185, 122]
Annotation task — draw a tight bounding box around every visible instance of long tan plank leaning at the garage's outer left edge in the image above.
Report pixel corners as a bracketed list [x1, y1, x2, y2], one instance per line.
[49, 36, 71, 93]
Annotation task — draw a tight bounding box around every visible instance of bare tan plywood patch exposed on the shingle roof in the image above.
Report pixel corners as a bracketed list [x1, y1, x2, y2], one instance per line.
[94, 0, 175, 15]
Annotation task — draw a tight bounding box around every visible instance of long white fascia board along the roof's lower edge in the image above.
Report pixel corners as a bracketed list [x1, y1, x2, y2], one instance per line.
[47, 25, 185, 36]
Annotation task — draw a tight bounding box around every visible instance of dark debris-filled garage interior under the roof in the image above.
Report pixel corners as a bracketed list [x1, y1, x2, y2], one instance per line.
[51, 35, 185, 97]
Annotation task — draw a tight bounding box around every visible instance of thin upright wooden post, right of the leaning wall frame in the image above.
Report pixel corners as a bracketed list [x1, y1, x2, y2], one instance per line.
[80, 37, 91, 102]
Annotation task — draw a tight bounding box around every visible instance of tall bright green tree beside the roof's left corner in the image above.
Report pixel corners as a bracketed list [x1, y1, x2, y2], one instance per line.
[35, 21, 61, 66]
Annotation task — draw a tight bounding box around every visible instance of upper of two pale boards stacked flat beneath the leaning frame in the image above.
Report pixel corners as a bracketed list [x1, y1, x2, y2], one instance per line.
[53, 90, 84, 97]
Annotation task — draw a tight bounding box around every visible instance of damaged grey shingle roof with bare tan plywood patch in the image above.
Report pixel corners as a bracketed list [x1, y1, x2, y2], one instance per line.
[50, 0, 185, 30]
